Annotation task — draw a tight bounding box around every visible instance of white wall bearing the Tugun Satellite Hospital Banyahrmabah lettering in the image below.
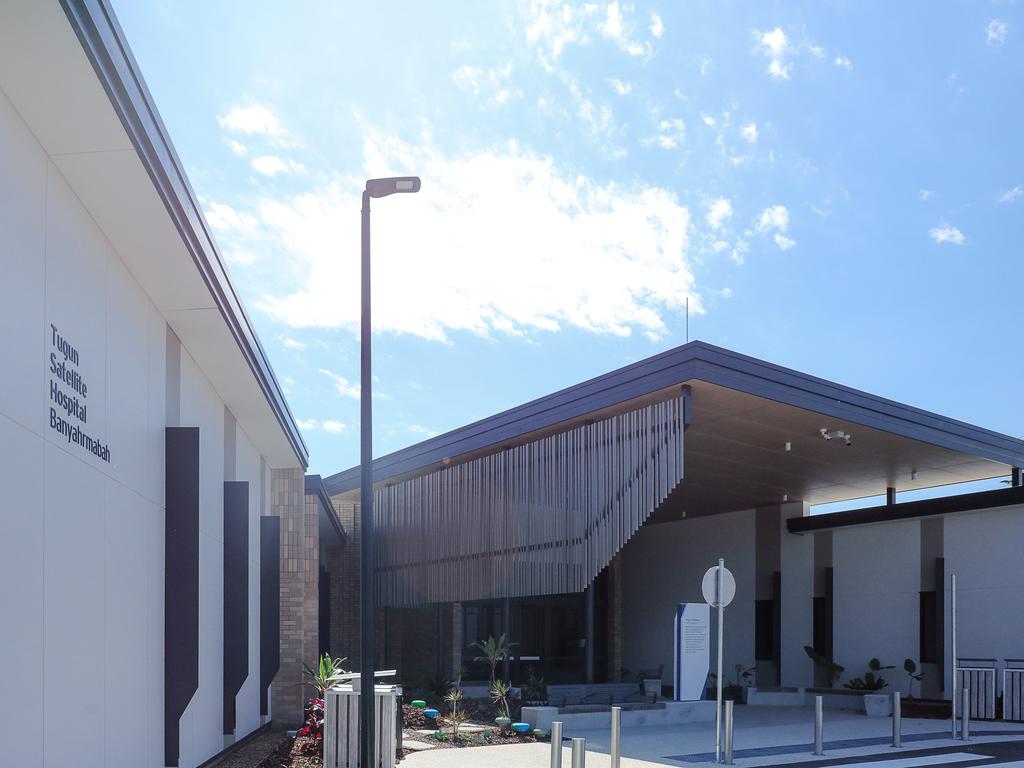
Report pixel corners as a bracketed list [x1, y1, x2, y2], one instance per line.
[0, 73, 269, 768]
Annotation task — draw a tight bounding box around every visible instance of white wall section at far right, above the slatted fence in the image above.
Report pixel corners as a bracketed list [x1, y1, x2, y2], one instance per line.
[942, 506, 1024, 695]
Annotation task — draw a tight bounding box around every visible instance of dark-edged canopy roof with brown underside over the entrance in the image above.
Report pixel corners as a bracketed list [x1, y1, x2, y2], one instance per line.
[325, 342, 1024, 520]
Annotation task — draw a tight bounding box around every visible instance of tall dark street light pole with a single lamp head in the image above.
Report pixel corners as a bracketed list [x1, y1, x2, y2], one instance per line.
[359, 176, 420, 768]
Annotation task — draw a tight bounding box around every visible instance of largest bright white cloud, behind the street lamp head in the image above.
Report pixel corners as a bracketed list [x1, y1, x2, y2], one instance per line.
[235, 130, 701, 342]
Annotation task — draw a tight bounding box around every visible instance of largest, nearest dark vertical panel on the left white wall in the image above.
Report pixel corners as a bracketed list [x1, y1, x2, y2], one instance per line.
[164, 427, 200, 766]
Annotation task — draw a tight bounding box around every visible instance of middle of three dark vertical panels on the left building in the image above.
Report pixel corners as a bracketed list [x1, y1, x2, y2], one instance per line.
[224, 480, 249, 735]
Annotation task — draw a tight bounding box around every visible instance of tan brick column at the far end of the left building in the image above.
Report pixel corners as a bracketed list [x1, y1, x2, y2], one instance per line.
[270, 469, 318, 725]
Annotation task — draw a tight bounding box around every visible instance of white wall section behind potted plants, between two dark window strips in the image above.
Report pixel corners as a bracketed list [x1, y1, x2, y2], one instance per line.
[833, 520, 921, 691]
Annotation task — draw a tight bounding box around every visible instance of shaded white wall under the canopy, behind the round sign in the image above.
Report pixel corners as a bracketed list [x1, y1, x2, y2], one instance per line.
[623, 510, 755, 684]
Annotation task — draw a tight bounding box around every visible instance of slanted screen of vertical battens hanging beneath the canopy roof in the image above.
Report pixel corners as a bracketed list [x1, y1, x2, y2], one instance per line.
[374, 394, 685, 606]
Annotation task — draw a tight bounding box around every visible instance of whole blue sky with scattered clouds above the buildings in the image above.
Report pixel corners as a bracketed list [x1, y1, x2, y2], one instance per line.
[114, 0, 1024, 475]
